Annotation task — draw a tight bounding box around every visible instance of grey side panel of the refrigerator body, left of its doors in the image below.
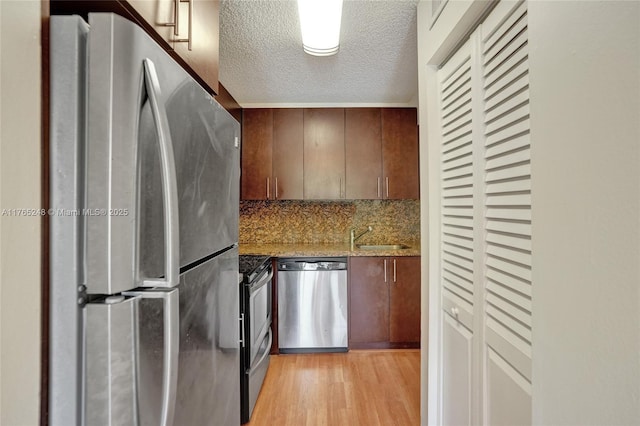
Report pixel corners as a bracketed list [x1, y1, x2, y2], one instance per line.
[49, 16, 89, 426]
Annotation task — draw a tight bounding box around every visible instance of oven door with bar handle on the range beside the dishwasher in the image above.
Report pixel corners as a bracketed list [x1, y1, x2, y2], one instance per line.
[247, 265, 273, 366]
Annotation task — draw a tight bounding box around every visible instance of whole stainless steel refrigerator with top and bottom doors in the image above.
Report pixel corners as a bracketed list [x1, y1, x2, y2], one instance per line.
[48, 14, 240, 426]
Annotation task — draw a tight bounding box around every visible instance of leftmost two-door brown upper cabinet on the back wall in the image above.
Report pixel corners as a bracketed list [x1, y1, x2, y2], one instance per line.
[241, 108, 303, 200]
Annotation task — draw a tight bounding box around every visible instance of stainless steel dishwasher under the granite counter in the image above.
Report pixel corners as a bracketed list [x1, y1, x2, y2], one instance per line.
[278, 257, 348, 353]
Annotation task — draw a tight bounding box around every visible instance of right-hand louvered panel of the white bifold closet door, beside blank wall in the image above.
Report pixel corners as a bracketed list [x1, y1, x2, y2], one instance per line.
[480, 2, 532, 425]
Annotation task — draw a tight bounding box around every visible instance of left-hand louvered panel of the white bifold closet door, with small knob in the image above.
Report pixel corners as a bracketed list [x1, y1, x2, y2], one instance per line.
[438, 42, 477, 425]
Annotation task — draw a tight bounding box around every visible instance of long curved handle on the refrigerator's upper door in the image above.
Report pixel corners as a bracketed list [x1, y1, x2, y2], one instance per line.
[142, 58, 180, 287]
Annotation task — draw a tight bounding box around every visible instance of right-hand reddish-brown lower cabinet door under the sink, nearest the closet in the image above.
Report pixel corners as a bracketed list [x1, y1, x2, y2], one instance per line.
[388, 257, 420, 343]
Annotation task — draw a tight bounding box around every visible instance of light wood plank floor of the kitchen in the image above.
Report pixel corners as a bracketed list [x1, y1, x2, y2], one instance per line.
[247, 349, 420, 426]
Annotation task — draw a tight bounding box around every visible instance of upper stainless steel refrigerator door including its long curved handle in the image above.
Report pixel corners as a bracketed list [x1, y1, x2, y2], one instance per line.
[85, 13, 240, 294]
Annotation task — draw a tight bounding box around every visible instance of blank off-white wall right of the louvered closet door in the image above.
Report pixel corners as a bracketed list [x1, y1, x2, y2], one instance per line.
[529, 1, 640, 425]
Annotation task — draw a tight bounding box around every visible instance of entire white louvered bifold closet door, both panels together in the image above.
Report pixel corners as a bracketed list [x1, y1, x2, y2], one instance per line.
[438, 1, 532, 425]
